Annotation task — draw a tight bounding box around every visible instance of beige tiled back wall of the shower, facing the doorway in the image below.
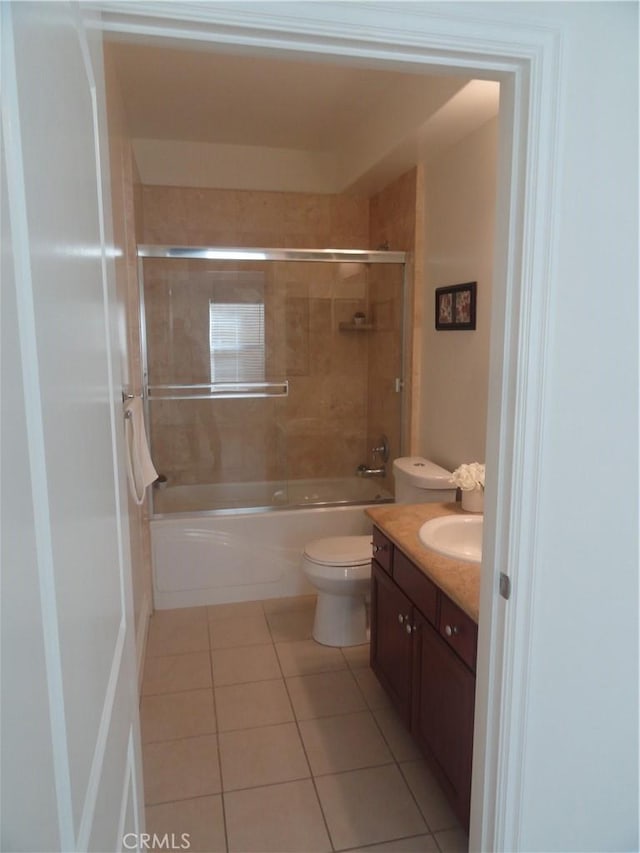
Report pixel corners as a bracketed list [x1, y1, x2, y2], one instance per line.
[143, 192, 369, 483]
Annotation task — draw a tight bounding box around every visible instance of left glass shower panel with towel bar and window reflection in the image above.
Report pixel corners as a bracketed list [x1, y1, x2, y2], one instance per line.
[143, 258, 287, 512]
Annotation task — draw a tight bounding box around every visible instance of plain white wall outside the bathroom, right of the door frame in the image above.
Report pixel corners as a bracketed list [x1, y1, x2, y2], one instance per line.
[496, 3, 638, 851]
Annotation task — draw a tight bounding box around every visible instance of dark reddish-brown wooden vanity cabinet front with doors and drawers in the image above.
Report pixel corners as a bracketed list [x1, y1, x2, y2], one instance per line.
[371, 528, 477, 829]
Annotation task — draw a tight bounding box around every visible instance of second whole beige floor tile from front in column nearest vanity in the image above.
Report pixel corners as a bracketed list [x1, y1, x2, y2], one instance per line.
[299, 711, 393, 776]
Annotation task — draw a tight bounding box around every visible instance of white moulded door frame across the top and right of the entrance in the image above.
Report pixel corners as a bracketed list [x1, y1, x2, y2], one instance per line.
[91, 5, 562, 851]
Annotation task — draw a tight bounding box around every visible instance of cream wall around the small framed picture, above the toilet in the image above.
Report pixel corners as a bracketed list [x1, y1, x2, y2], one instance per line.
[419, 119, 498, 470]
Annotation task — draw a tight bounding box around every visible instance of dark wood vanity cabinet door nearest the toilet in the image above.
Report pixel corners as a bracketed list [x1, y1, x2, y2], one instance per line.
[371, 561, 413, 726]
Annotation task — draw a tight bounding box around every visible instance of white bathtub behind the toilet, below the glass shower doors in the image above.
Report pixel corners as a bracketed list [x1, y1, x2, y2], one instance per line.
[150, 478, 393, 610]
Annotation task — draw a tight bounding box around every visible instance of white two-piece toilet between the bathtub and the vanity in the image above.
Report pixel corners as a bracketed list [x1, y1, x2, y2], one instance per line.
[302, 456, 456, 646]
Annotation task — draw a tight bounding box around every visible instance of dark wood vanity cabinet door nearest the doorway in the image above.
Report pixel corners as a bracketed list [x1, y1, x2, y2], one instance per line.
[412, 614, 475, 828]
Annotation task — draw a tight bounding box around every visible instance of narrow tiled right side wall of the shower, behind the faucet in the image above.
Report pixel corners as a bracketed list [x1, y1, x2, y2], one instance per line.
[367, 167, 422, 489]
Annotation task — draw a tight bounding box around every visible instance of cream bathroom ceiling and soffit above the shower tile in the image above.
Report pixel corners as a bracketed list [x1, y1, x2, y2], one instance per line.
[107, 41, 498, 192]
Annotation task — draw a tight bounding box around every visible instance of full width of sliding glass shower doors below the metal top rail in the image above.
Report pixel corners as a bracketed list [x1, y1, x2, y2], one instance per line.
[142, 253, 404, 513]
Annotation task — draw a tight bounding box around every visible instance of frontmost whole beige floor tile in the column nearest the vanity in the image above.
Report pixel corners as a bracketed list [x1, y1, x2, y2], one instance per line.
[315, 764, 428, 850]
